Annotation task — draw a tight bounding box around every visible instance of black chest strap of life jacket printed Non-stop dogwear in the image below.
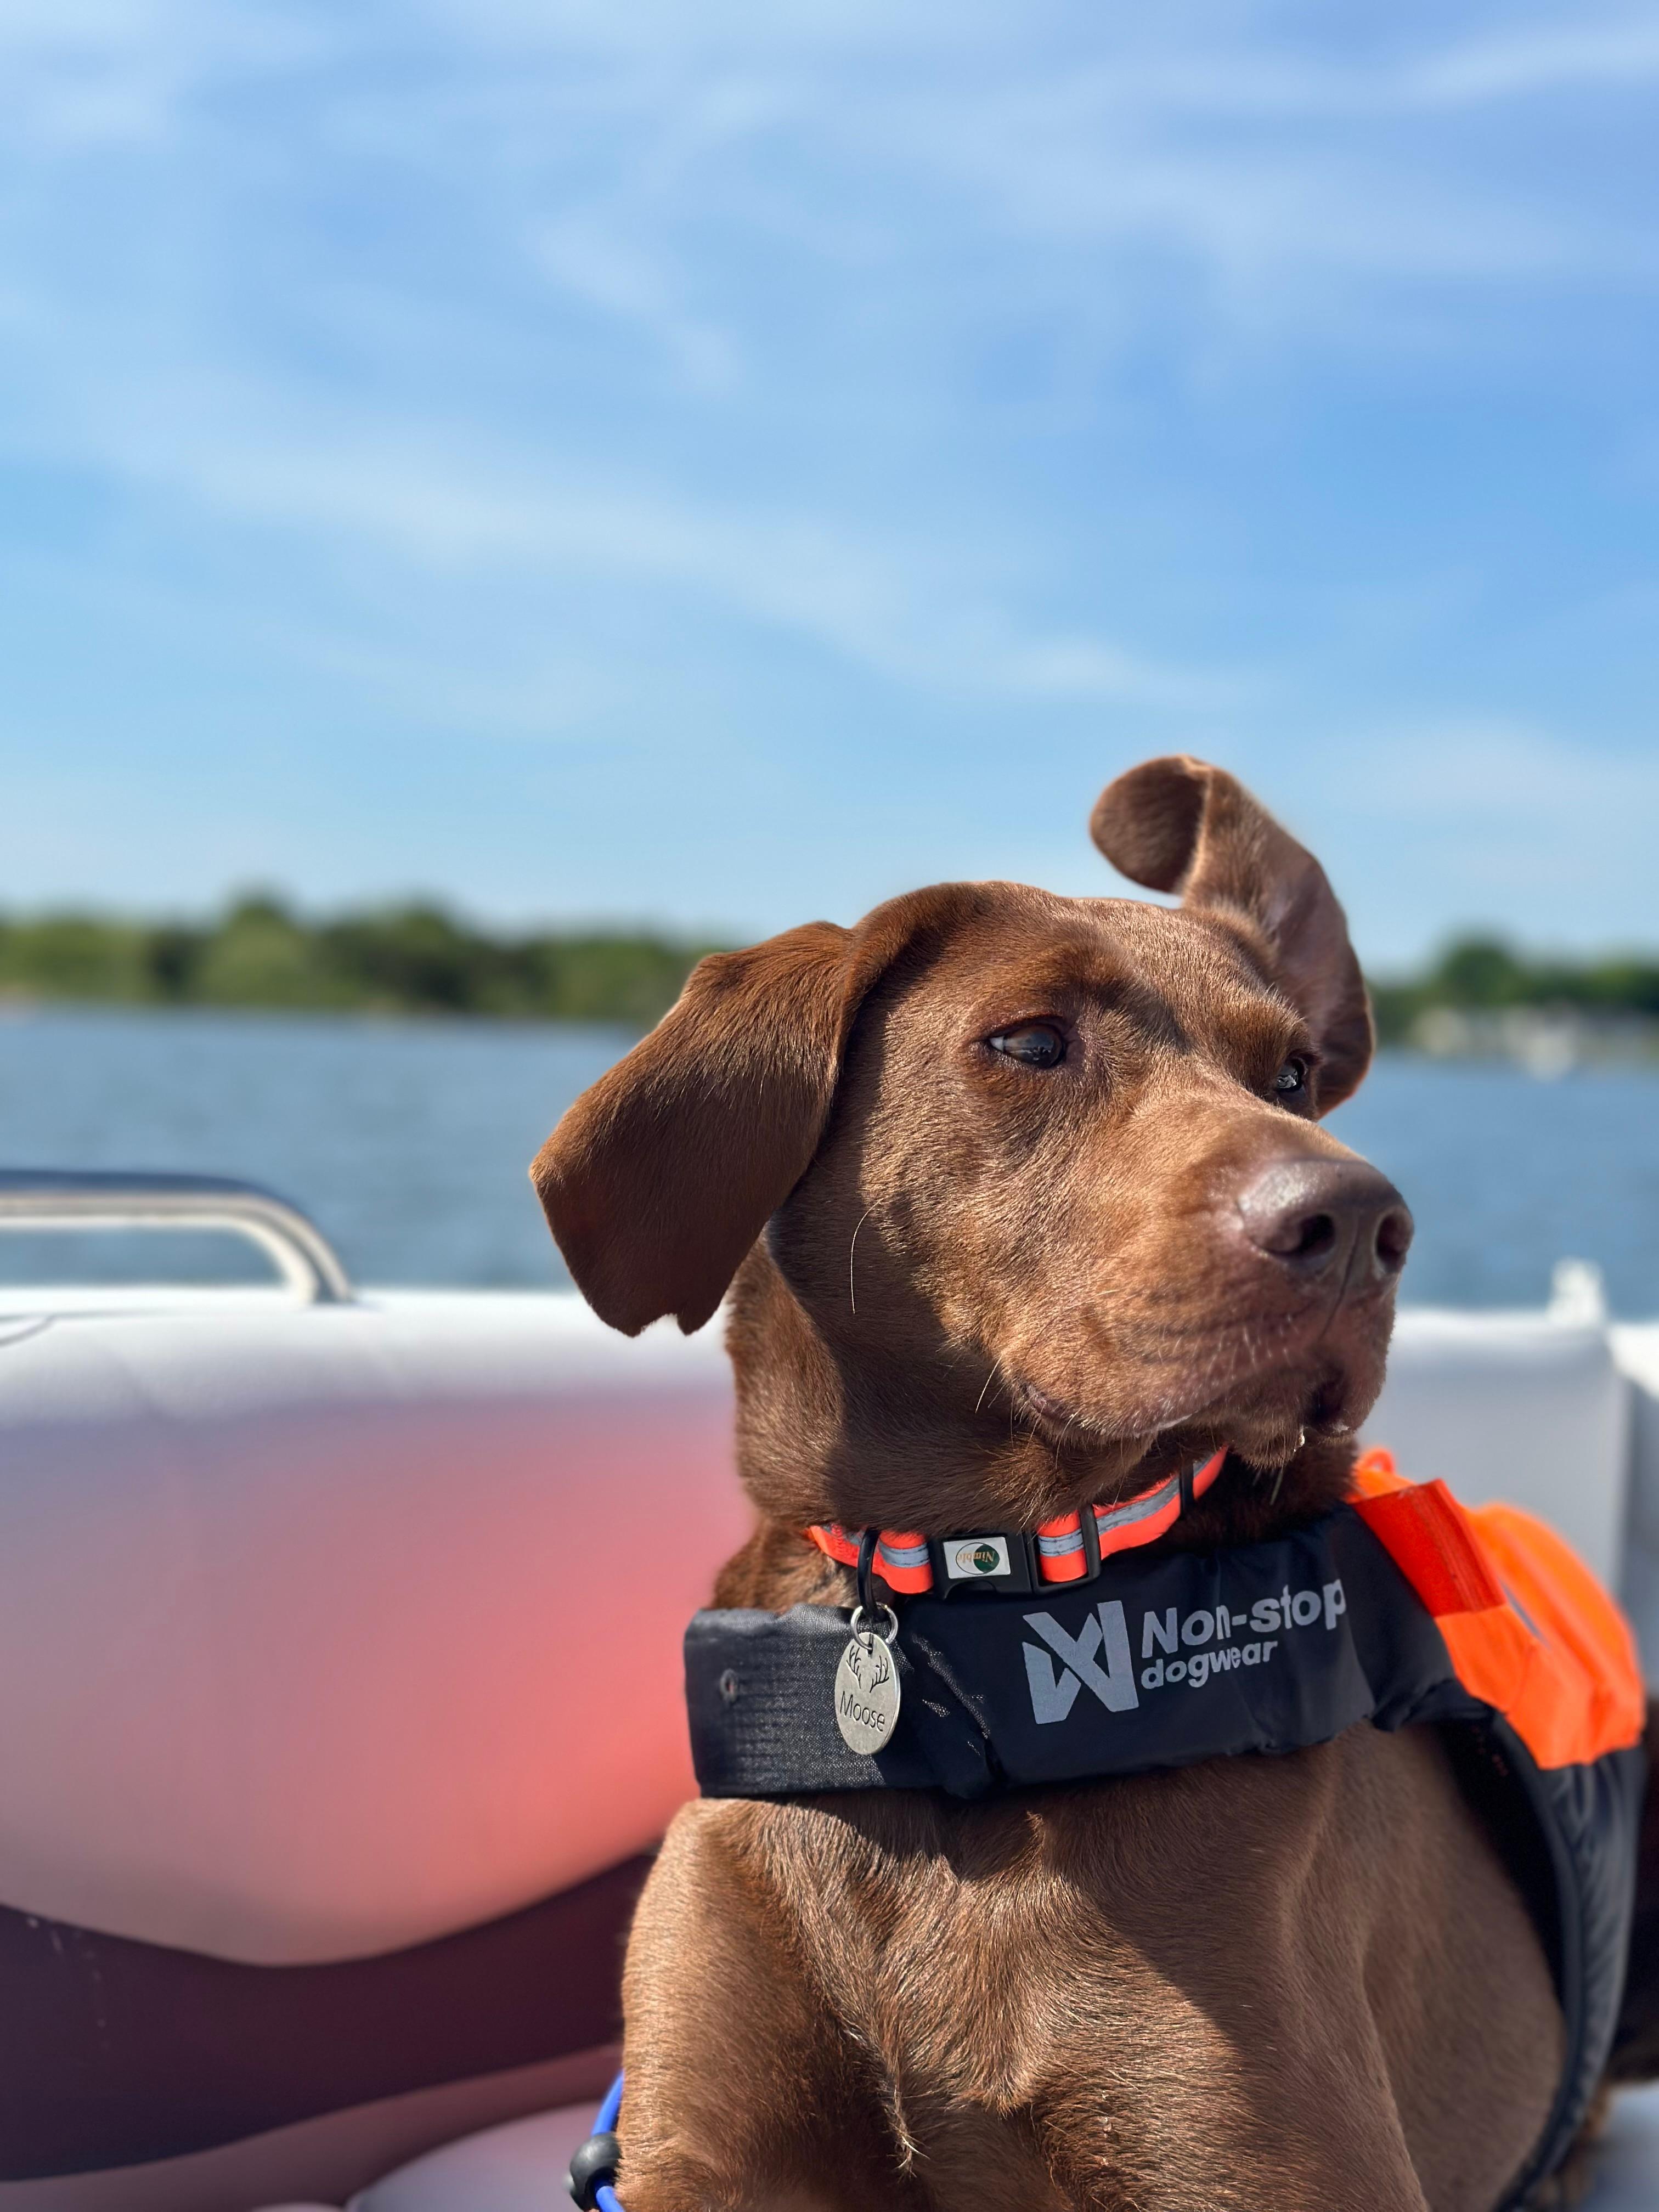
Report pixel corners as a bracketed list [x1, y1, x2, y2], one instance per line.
[686, 1509, 1484, 1796]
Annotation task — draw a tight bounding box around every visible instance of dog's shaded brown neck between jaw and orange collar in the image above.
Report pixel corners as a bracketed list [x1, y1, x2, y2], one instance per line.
[723, 1248, 1354, 1604]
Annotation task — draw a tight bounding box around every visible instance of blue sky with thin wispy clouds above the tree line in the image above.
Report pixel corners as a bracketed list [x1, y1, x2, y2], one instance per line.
[0, 0, 1659, 964]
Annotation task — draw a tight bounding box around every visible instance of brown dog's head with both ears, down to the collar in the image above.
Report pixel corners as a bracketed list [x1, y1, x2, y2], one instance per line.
[533, 757, 1411, 1528]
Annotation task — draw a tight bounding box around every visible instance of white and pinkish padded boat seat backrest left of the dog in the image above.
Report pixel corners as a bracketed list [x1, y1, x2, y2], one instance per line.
[0, 1292, 750, 1966]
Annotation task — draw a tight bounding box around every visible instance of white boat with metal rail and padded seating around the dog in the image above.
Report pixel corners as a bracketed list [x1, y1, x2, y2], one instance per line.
[0, 1172, 1659, 2212]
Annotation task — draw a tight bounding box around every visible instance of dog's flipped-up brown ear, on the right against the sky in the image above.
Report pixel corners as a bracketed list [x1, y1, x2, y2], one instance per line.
[1088, 752, 1374, 1113]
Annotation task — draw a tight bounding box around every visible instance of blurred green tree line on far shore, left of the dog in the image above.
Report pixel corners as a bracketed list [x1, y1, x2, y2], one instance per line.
[0, 896, 714, 1029]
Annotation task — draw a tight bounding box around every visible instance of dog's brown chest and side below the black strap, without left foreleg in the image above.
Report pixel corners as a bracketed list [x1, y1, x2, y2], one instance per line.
[646, 1728, 1560, 2212]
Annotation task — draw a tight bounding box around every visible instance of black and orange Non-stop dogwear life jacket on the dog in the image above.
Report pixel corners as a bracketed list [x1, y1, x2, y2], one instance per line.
[686, 1453, 1646, 2205]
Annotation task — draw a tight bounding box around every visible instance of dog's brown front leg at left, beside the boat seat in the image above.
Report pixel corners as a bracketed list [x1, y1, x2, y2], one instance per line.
[617, 1801, 920, 2212]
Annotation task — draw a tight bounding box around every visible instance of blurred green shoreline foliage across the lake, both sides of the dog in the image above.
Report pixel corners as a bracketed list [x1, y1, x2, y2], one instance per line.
[0, 894, 1659, 1044]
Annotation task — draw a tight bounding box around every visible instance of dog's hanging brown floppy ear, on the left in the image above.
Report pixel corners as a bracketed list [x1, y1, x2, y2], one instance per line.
[531, 885, 973, 1336]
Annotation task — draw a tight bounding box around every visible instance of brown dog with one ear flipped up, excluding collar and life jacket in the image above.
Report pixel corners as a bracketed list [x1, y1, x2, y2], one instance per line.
[533, 759, 1659, 2212]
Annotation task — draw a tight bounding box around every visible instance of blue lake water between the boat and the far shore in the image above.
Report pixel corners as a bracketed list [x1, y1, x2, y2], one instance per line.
[0, 1009, 1659, 1316]
